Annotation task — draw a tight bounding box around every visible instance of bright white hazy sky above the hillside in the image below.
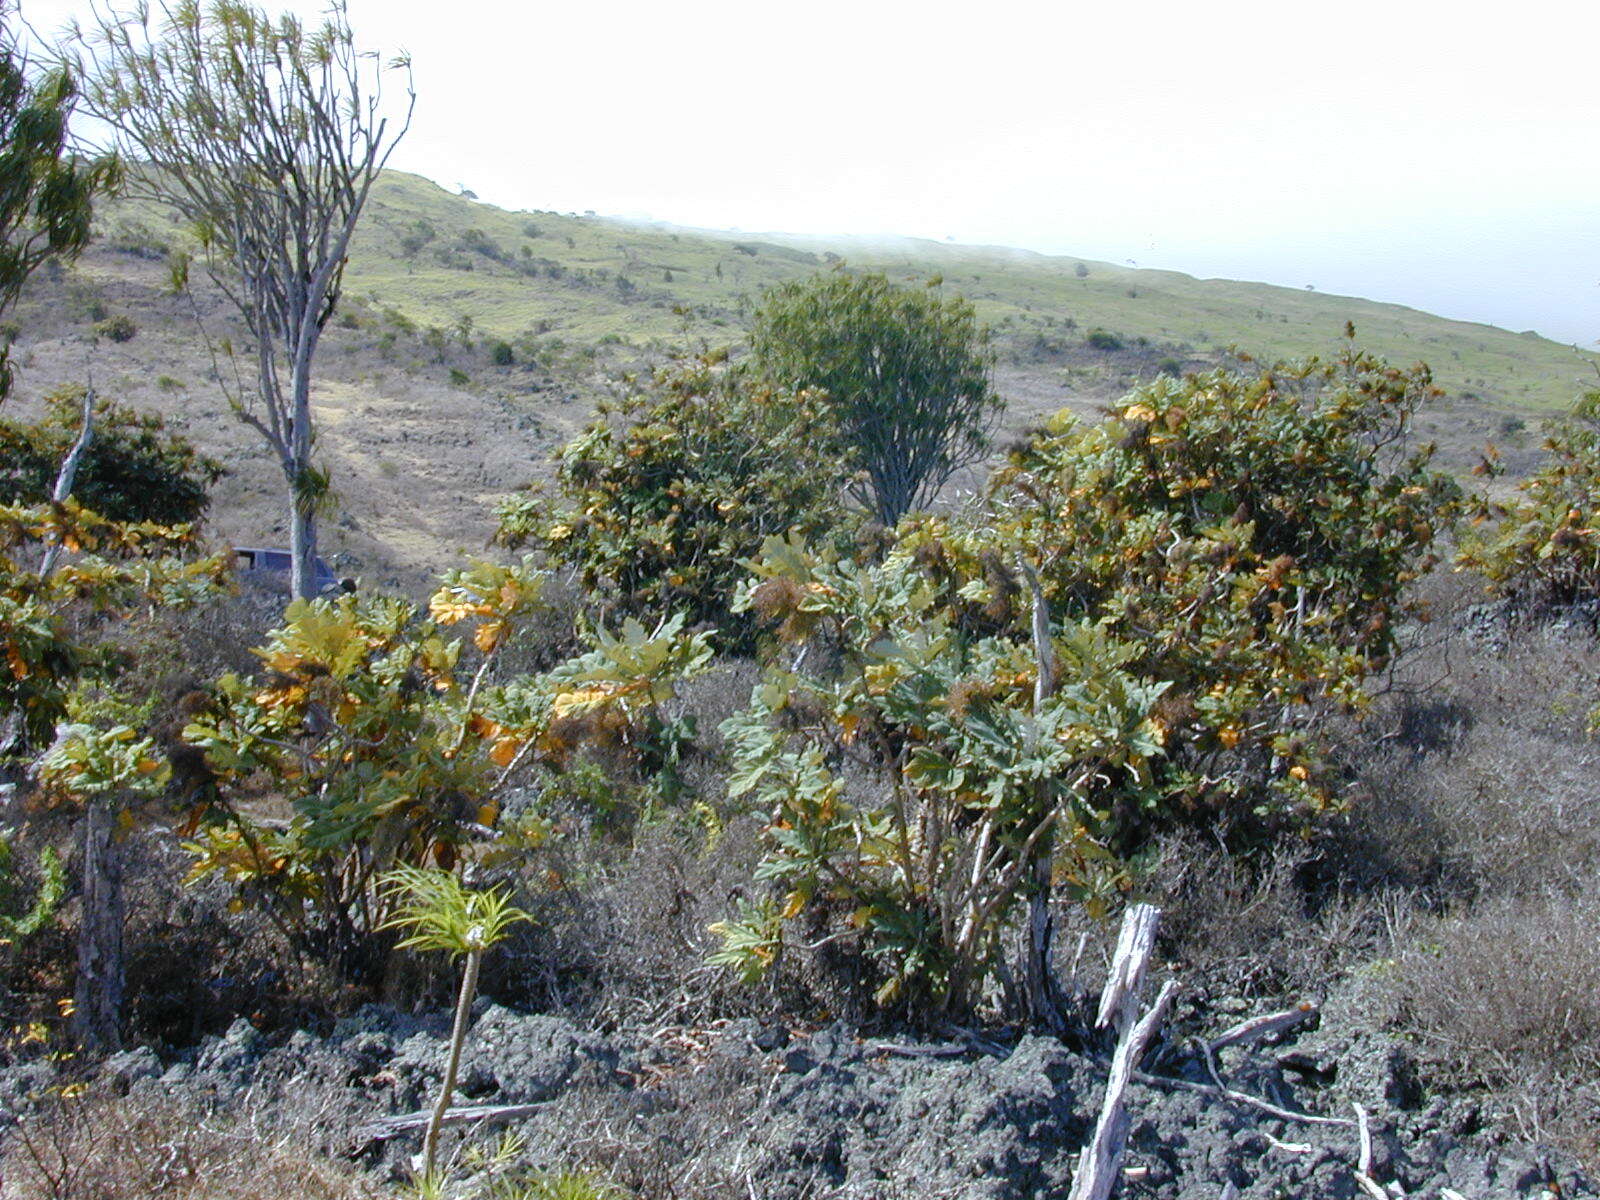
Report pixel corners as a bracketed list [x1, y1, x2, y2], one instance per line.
[12, 0, 1600, 347]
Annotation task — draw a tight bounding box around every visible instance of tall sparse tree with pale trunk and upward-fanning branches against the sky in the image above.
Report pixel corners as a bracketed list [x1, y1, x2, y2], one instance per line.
[66, 0, 416, 597]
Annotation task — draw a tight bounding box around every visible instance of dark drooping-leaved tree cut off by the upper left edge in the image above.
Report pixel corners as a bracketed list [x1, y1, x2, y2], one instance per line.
[0, 9, 117, 398]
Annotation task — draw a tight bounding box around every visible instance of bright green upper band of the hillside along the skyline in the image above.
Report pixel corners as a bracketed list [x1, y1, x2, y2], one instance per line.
[337, 174, 1594, 413]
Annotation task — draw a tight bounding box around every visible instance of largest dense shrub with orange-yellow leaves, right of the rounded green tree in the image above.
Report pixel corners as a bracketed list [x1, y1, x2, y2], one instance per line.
[928, 334, 1461, 848]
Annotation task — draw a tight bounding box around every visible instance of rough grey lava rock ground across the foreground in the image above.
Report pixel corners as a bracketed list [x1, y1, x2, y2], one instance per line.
[0, 966, 1595, 1200]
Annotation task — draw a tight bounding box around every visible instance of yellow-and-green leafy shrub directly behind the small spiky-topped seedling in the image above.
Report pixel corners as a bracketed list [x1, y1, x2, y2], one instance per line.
[184, 563, 710, 981]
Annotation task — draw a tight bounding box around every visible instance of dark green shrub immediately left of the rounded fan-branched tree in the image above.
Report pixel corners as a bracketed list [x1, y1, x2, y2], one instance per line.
[498, 354, 840, 650]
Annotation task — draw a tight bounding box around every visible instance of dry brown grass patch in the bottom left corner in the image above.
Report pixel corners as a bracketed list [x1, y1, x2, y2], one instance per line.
[0, 1094, 376, 1200]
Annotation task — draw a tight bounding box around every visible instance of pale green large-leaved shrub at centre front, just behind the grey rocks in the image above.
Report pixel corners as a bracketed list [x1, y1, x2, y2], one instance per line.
[714, 539, 1163, 1016]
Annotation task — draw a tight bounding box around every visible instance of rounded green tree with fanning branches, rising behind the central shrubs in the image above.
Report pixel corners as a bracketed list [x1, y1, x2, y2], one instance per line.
[752, 270, 1005, 525]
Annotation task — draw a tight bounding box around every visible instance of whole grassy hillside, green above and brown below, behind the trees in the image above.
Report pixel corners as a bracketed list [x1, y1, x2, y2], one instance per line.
[8, 174, 1595, 582]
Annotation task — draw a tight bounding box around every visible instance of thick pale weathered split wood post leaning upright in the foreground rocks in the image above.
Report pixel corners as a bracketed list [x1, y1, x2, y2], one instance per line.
[1067, 904, 1178, 1200]
